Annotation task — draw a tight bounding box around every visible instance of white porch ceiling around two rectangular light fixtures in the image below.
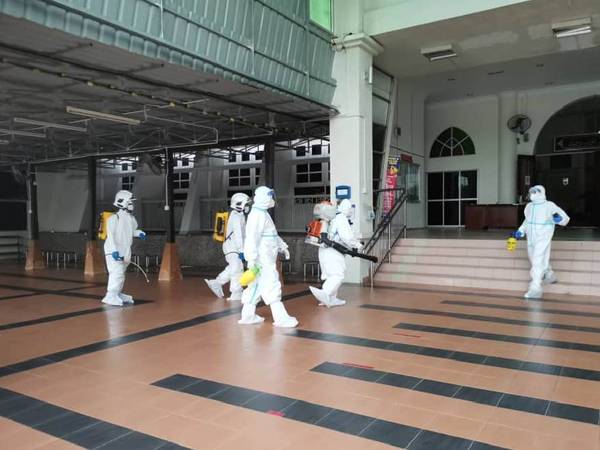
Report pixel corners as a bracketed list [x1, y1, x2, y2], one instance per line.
[375, 0, 600, 100]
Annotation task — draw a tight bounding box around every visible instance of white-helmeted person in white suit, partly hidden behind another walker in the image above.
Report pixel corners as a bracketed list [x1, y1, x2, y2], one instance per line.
[204, 192, 250, 301]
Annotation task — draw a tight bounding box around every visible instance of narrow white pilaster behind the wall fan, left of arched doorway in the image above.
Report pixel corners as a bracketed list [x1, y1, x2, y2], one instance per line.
[498, 91, 518, 203]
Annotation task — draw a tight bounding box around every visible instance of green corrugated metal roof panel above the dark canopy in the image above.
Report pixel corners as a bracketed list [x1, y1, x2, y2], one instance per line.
[0, 0, 335, 106]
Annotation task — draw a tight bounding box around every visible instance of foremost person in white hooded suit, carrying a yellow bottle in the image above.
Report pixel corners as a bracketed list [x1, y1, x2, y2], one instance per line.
[238, 186, 298, 328]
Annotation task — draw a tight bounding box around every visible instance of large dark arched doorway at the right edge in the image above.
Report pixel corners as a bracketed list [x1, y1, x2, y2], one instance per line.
[534, 96, 600, 227]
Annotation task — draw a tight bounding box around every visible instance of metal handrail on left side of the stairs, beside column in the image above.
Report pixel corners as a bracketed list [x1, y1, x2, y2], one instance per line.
[365, 188, 408, 287]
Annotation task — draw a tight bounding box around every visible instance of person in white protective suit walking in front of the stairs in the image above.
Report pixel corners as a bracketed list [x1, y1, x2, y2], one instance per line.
[514, 186, 570, 298]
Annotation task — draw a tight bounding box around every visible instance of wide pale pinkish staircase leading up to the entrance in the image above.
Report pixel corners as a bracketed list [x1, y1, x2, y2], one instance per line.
[375, 239, 600, 297]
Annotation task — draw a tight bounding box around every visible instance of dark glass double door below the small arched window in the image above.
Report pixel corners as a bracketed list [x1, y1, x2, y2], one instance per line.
[427, 170, 477, 227]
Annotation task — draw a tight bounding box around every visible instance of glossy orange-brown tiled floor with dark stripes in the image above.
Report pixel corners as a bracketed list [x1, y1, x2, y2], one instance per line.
[0, 265, 600, 450]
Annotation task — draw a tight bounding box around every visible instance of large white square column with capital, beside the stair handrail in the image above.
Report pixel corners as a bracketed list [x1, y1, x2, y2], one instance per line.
[329, 33, 383, 283]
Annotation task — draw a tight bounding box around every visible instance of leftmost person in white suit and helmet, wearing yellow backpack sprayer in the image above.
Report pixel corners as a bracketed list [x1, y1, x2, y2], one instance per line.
[102, 191, 146, 306]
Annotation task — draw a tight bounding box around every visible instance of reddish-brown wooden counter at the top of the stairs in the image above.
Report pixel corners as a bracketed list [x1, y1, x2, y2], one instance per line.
[465, 205, 525, 230]
